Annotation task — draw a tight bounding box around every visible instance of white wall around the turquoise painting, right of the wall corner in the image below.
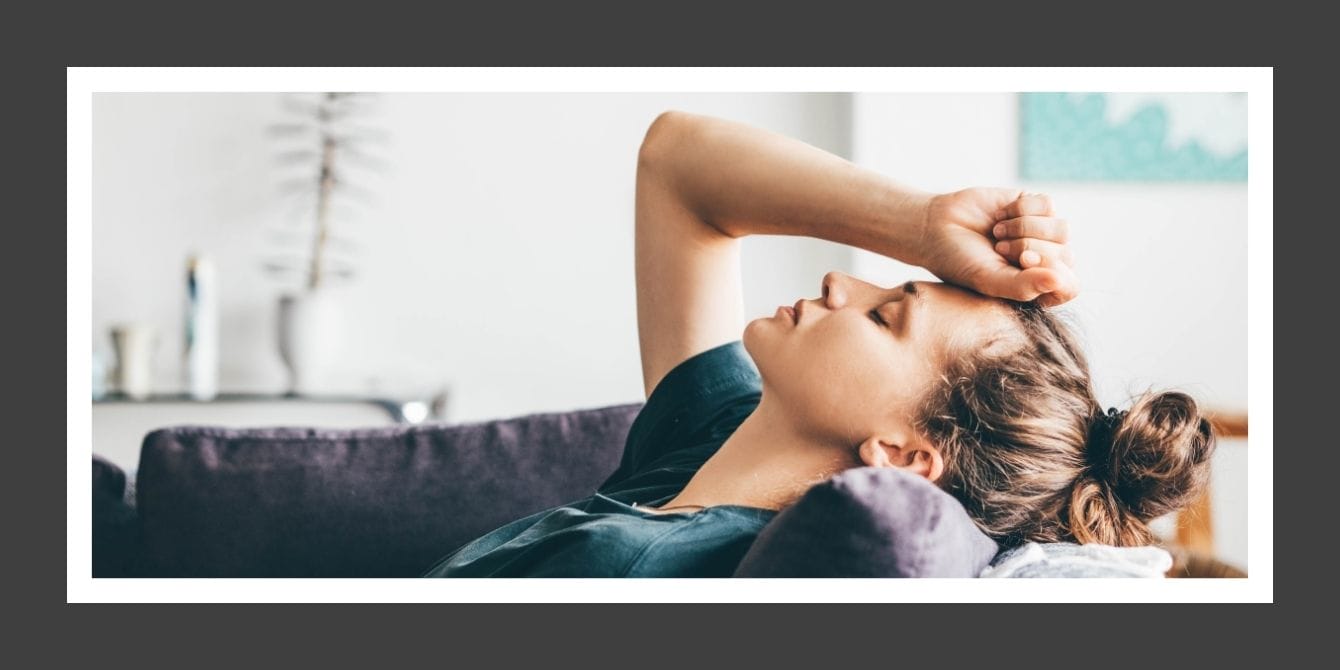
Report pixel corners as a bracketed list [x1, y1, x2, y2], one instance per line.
[852, 94, 1248, 565]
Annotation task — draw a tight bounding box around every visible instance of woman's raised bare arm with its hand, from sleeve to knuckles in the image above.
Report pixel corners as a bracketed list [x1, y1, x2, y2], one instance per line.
[635, 111, 1068, 395]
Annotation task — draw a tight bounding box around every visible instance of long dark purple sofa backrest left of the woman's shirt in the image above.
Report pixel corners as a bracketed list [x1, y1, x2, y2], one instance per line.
[137, 403, 642, 578]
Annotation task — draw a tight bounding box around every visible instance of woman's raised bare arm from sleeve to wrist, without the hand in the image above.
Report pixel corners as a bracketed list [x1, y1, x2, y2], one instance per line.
[635, 113, 929, 395]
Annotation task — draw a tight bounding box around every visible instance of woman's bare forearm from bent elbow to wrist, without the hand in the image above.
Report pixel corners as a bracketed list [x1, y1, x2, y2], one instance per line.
[641, 113, 931, 264]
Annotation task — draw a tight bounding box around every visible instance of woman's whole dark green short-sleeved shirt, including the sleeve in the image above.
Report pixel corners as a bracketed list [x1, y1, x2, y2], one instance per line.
[423, 340, 776, 578]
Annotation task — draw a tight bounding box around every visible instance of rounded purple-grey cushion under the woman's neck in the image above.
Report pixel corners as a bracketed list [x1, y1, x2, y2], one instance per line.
[736, 468, 998, 578]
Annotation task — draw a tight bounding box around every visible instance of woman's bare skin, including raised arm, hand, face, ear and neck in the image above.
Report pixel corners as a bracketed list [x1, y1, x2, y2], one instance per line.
[634, 113, 1079, 511]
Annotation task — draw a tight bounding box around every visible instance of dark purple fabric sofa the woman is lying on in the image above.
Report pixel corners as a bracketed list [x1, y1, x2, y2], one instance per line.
[92, 403, 1166, 578]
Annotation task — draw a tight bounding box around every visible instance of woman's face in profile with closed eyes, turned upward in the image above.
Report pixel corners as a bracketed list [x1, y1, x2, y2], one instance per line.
[744, 272, 1021, 444]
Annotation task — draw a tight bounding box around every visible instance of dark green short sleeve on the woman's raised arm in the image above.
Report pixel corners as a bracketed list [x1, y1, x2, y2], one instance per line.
[599, 340, 762, 490]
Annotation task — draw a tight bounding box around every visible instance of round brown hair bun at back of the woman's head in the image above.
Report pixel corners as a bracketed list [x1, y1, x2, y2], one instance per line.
[1087, 391, 1214, 521]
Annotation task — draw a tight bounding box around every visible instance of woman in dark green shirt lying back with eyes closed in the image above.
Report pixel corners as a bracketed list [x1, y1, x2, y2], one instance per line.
[427, 113, 1214, 576]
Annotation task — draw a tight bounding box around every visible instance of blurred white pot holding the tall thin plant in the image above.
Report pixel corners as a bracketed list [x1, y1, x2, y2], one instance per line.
[279, 289, 344, 395]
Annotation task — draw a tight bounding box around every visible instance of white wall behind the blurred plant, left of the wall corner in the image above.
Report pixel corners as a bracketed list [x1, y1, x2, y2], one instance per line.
[92, 94, 851, 421]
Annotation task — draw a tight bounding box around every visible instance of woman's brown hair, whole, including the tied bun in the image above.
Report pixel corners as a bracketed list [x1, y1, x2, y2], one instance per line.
[919, 303, 1215, 545]
